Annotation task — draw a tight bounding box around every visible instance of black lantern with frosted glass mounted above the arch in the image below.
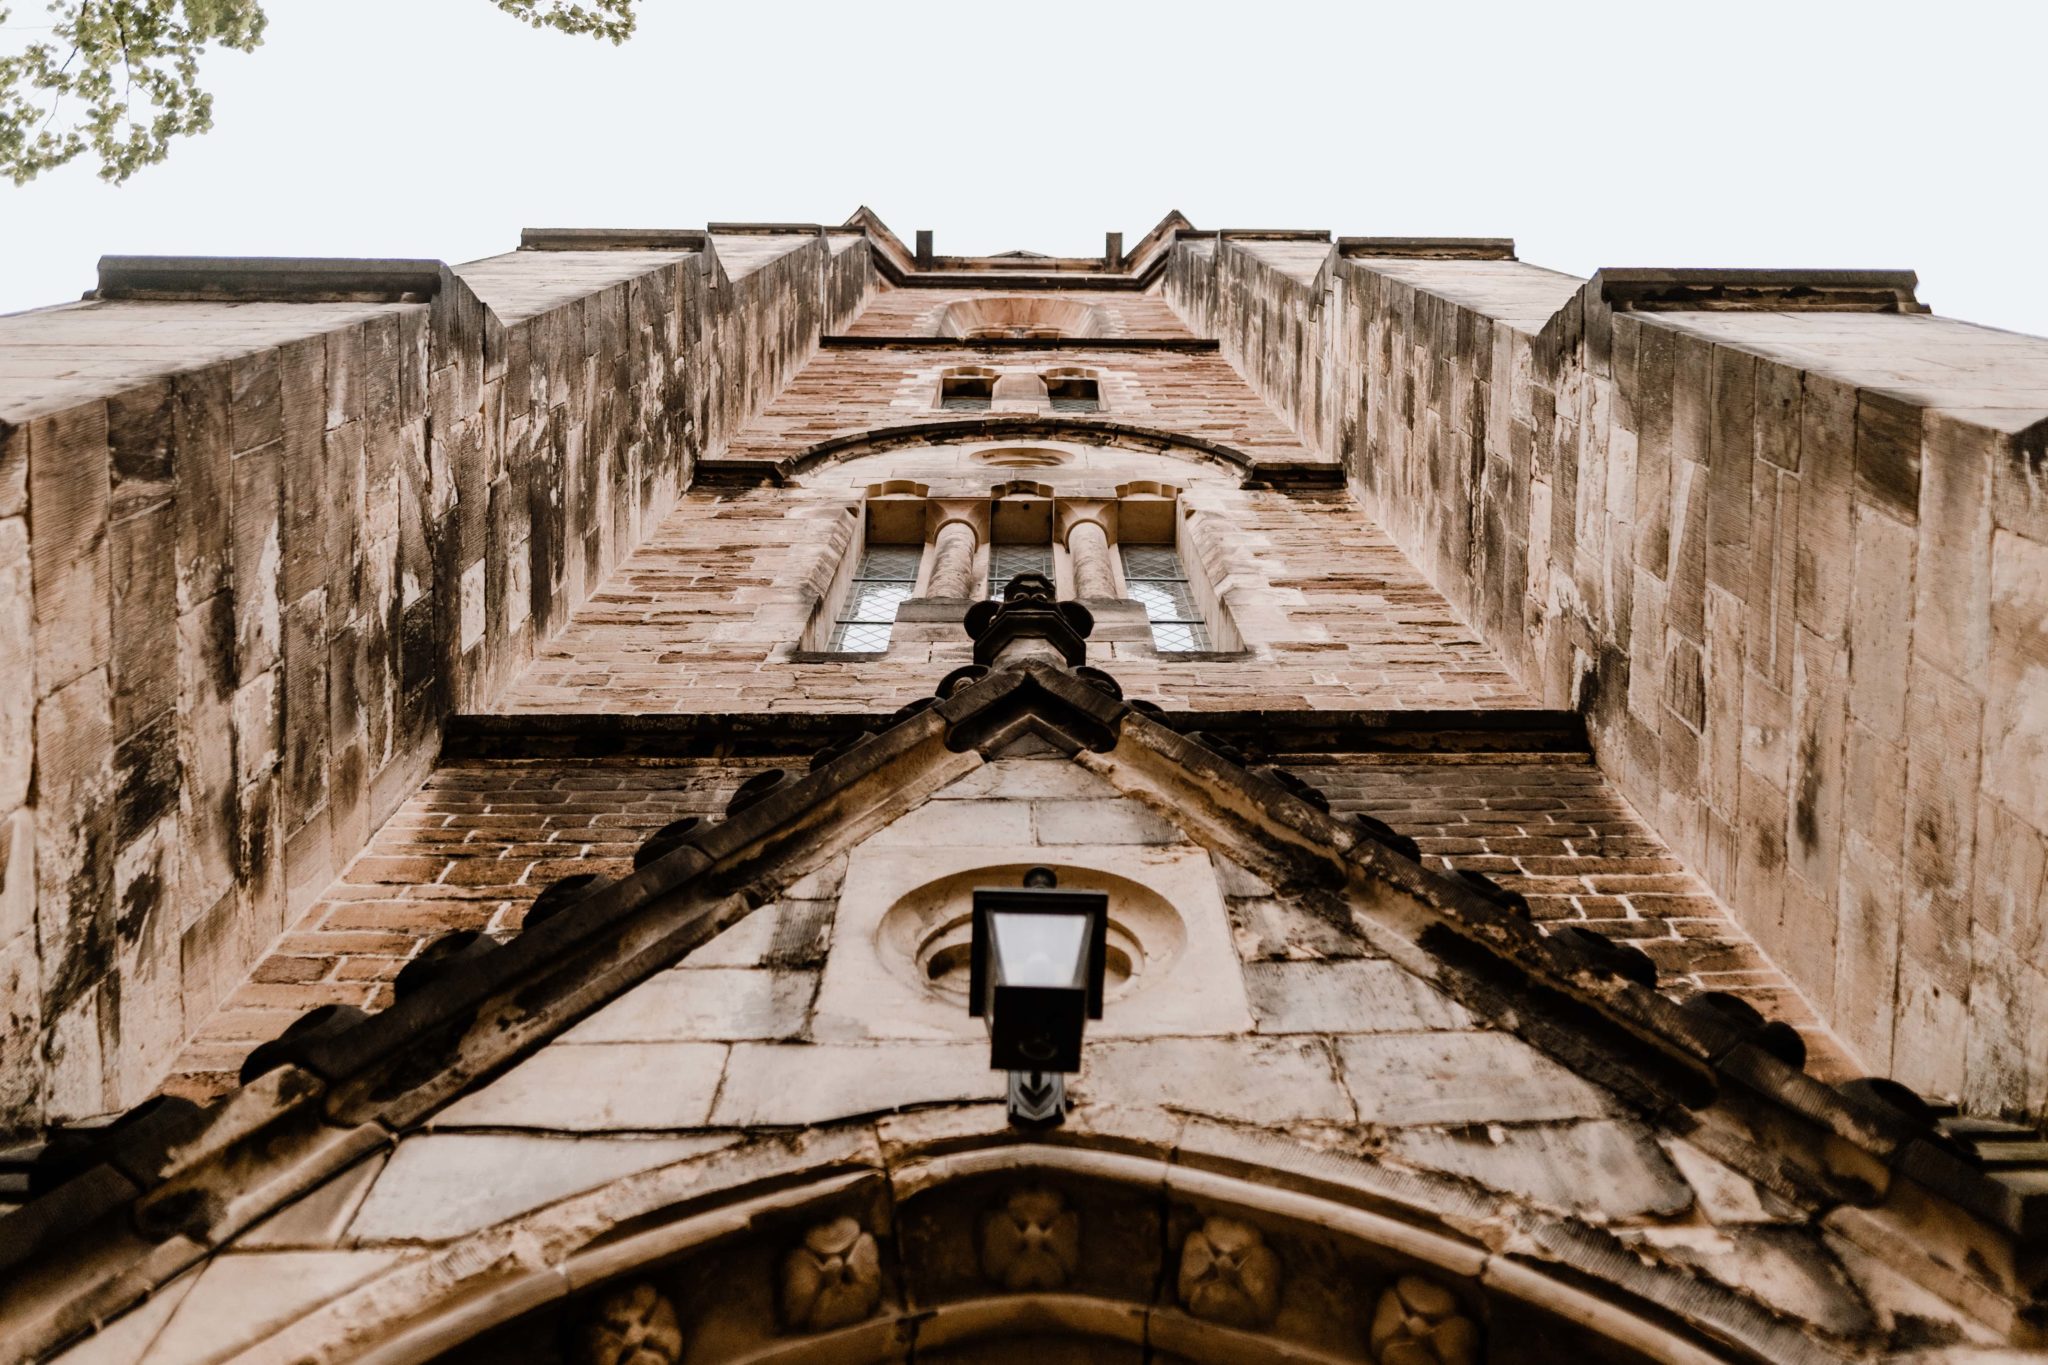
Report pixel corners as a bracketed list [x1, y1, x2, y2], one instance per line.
[967, 868, 1110, 1124]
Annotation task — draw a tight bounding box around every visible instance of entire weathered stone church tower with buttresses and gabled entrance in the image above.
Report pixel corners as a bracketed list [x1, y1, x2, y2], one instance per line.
[0, 211, 2048, 1365]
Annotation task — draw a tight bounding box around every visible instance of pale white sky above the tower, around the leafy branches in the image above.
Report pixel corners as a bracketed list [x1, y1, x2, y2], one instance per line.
[0, 0, 2048, 334]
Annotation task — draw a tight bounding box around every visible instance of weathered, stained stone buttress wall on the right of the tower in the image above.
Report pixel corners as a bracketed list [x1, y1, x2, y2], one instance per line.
[1167, 241, 2048, 1115]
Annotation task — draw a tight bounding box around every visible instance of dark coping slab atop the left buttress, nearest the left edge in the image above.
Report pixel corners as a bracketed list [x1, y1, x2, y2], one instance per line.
[96, 256, 449, 303]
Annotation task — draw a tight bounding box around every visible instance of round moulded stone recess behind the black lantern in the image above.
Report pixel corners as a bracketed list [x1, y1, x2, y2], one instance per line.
[874, 864, 1188, 1003]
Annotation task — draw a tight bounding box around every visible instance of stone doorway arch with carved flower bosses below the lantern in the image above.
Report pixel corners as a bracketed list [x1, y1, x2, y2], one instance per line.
[327, 1144, 1751, 1365]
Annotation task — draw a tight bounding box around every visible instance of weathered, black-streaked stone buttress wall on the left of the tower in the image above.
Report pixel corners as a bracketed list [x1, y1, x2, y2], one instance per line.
[0, 237, 868, 1130]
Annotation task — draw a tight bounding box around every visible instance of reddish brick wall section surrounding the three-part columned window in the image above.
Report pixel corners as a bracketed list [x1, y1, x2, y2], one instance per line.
[500, 448, 1532, 714]
